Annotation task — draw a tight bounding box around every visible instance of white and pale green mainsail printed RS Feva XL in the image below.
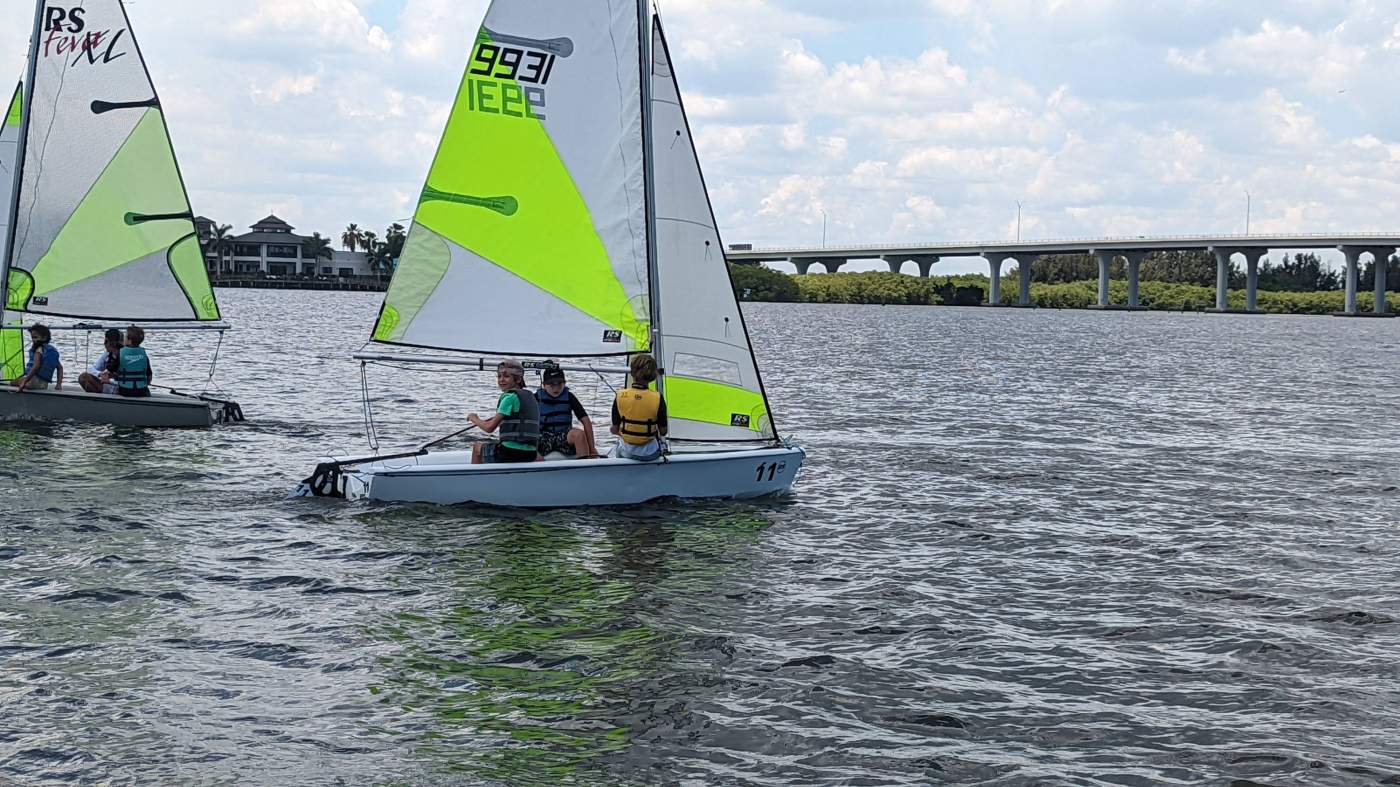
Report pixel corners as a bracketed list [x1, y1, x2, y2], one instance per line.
[8, 0, 220, 322]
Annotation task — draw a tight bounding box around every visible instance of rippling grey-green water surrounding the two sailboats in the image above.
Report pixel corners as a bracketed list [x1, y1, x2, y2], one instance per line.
[0, 291, 1400, 784]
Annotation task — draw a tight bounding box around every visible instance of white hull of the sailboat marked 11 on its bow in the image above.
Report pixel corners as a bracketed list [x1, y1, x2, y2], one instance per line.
[333, 447, 805, 508]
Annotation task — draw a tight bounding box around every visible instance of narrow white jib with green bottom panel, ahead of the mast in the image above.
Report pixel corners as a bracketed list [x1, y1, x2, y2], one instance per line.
[650, 18, 774, 441]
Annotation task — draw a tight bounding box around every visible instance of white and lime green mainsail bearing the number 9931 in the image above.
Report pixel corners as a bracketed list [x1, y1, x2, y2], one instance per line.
[372, 0, 650, 357]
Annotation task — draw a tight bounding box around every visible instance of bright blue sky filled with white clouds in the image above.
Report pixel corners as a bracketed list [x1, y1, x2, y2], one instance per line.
[0, 0, 1400, 273]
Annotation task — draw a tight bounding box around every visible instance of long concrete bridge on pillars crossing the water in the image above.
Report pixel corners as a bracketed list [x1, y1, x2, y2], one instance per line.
[725, 232, 1400, 316]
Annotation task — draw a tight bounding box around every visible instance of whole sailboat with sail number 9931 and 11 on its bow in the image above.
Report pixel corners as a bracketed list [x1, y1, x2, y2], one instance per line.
[298, 0, 805, 507]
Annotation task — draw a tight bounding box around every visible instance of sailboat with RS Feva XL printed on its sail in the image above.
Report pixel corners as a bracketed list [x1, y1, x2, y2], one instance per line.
[0, 0, 241, 427]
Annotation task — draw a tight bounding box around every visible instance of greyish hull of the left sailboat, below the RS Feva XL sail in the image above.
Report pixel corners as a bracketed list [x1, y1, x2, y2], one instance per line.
[0, 386, 217, 429]
